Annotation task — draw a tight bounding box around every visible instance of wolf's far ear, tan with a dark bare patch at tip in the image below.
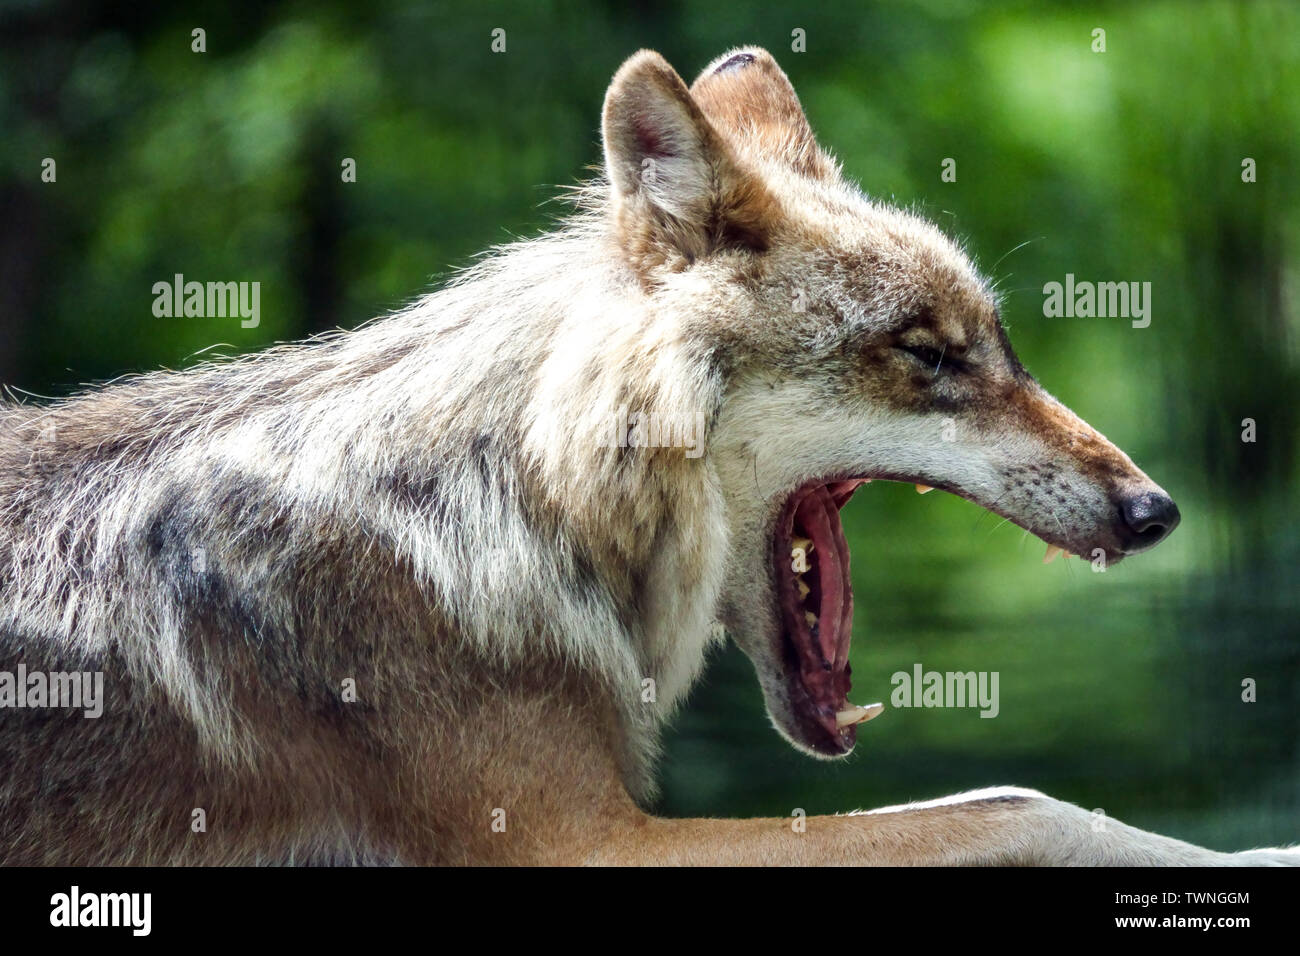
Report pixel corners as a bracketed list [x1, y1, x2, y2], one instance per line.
[690, 47, 840, 179]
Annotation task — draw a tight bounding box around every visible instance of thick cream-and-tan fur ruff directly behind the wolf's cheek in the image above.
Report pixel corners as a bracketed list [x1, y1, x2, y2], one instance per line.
[454, 218, 727, 702]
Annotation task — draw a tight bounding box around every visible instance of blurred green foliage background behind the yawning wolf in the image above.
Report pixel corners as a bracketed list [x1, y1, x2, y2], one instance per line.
[0, 0, 1300, 848]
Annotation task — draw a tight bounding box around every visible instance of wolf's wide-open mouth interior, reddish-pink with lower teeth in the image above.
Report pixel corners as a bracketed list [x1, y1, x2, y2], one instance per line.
[772, 479, 883, 757]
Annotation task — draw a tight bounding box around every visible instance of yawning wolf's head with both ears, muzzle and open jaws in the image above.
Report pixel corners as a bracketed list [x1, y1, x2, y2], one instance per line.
[603, 48, 1179, 757]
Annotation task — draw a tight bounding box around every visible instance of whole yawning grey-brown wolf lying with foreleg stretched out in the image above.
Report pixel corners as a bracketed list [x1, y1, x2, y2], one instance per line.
[0, 48, 1300, 865]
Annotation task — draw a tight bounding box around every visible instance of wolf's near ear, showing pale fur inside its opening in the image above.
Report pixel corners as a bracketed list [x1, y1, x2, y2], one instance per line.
[603, 49, 771, 260]
